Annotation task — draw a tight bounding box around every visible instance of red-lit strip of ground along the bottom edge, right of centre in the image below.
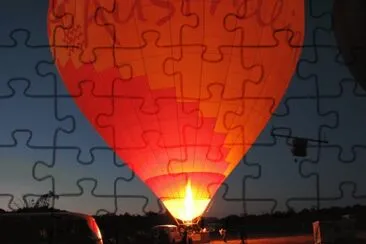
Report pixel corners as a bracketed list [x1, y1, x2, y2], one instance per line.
[211, 235, 314, 244]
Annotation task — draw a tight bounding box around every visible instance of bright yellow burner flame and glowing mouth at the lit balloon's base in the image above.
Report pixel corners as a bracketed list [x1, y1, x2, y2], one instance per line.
[163, 180, 211, 222]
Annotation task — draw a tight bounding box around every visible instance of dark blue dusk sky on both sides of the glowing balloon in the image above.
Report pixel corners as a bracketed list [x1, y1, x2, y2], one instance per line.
[0, 0, 366, 217]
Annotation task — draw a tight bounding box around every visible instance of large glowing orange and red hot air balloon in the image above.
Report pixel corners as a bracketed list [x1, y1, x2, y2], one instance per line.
[48, 0, 304, 223]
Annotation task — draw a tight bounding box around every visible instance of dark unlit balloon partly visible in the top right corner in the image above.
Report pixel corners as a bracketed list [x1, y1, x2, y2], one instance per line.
[333, 0, 366, 90]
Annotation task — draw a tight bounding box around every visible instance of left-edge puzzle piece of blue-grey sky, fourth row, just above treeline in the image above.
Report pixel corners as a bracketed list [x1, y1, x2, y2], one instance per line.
[0, 130, 53, 209]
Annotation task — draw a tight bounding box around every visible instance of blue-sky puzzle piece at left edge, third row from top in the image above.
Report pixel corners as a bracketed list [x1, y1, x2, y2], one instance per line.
[0, 79, 74, 146]
